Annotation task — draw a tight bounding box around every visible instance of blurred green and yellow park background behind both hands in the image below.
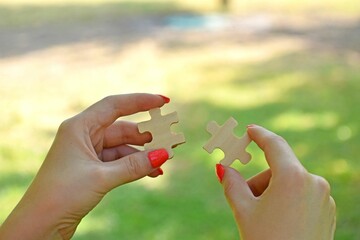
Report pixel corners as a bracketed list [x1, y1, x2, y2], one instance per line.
[0, 0, 360, 240]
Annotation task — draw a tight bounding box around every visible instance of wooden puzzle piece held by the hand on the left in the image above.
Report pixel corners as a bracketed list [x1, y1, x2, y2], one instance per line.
[138, 108, 185, 158]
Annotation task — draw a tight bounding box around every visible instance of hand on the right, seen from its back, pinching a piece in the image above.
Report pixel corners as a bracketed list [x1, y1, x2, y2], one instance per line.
[217, 125, 336, 240]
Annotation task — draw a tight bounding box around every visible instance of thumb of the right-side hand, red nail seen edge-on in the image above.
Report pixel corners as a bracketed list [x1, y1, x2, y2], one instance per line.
[216, 164, 255, 216]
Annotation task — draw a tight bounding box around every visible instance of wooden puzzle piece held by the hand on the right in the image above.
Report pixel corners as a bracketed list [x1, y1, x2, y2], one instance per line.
[203, 117, 251, 166]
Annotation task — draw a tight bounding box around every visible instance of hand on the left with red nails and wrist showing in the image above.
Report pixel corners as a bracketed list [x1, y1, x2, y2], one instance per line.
[0, 94, 168, 239]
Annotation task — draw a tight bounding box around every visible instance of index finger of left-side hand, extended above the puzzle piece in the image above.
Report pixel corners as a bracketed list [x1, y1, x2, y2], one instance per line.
[83, 93, 166, 131]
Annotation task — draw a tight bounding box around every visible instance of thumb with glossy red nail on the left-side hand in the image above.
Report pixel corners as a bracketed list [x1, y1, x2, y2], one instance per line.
[102, 149, 169, 189]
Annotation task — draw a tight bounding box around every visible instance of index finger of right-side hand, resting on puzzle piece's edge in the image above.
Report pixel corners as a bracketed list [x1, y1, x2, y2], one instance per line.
[248, 125, 303, 176]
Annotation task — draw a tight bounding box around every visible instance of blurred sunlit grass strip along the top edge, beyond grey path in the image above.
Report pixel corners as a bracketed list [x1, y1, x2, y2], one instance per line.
[0, 0, 360, 28]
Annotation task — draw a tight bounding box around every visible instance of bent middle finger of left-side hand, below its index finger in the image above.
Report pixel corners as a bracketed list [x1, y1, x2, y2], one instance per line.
[103, 121, 152, 148]
